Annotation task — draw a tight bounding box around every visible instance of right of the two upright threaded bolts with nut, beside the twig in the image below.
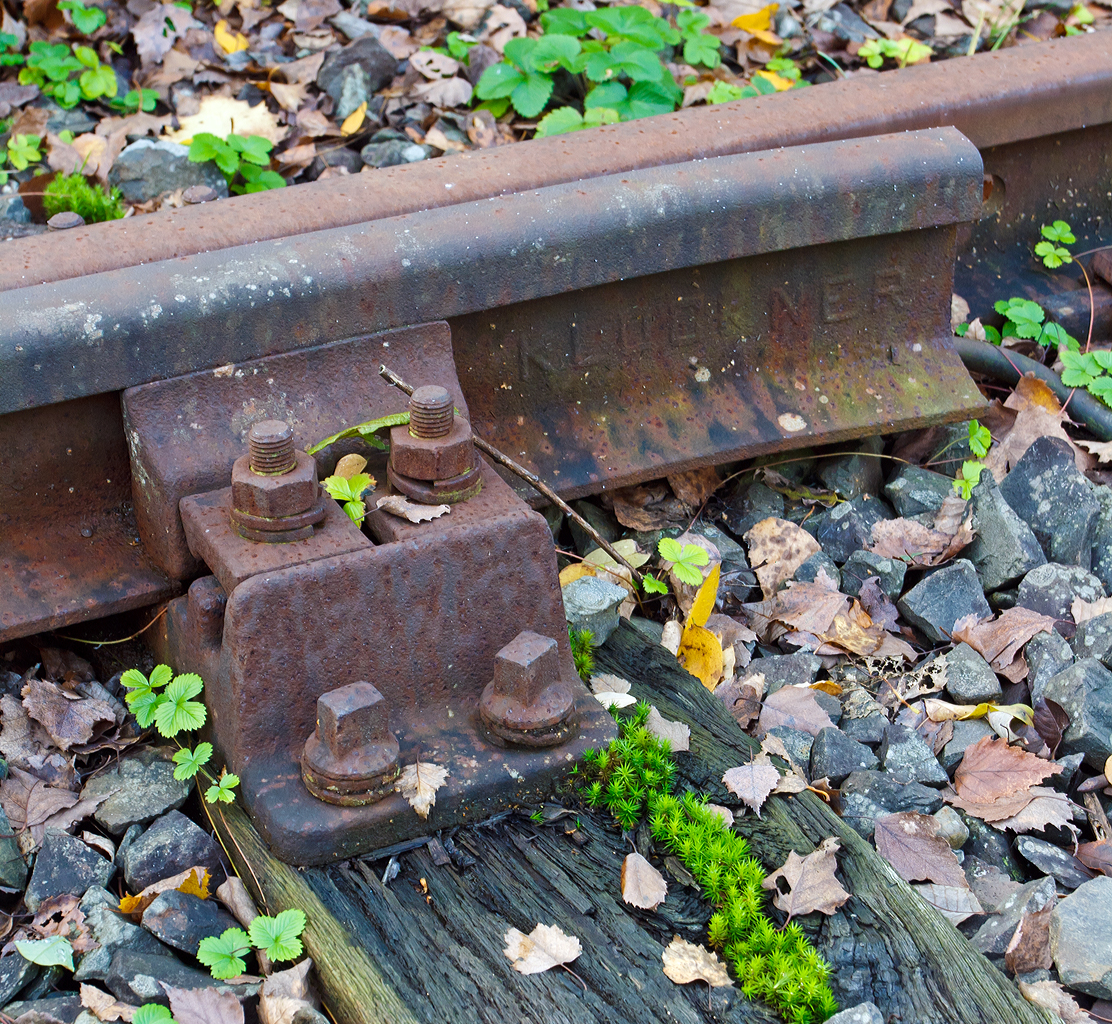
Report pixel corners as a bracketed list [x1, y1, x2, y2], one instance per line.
[387, 385, 483, 505]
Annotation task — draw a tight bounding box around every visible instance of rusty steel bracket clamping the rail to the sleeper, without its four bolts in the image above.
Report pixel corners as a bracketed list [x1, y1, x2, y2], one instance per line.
[136, 324, 616, 864]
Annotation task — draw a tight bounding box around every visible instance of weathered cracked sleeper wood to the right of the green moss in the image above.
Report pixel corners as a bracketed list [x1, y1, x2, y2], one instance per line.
[595, 622, 1051, 1024]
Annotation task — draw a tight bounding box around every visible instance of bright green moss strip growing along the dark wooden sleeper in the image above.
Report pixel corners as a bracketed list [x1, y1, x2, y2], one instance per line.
[575, 703, 837, 1024]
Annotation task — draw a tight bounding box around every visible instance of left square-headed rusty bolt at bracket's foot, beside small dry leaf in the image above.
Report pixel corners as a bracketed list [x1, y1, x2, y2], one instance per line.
[301, 682, 398, 807]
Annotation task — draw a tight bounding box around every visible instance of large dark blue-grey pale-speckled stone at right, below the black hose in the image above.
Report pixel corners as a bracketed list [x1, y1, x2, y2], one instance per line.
[1000, 437, 1101, 569]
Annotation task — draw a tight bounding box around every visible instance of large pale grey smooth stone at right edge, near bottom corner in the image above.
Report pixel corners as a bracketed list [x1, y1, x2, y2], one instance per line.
[1050, 875, 1112, 1000]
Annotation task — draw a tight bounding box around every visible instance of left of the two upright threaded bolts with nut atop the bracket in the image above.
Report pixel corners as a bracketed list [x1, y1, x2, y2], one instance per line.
[231, 419, 325, 544]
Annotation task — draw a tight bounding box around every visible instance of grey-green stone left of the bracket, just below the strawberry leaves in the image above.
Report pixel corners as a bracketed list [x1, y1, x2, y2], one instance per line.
[81, 747, 193, 836]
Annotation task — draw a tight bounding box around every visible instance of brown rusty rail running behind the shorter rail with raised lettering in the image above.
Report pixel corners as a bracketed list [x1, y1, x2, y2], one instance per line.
[0, 32, 1112, 290]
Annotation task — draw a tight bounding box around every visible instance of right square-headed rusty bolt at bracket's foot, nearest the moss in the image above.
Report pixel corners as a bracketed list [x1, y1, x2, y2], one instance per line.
[479, 630, 576, 747]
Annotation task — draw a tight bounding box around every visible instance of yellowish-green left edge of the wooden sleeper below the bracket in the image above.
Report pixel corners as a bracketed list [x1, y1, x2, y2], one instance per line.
[210, 804, 417, 1024]
